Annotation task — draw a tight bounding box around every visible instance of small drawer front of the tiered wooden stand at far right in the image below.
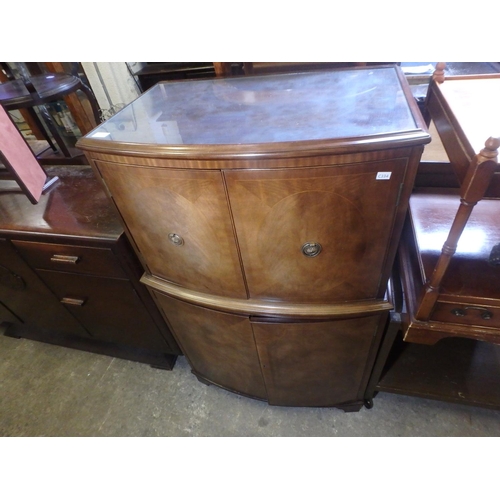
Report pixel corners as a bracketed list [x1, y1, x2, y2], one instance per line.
[431, 302, 500, 335]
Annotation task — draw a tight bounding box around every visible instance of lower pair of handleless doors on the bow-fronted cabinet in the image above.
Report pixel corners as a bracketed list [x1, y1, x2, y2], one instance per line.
[152, 290, 387, 406]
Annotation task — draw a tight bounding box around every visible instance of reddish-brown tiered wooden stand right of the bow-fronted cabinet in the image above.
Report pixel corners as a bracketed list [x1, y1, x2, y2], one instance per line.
[366, 70, 500, 409]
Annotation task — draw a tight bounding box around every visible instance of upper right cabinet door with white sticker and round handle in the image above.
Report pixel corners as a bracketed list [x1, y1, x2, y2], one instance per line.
[225, 159, 407, 303]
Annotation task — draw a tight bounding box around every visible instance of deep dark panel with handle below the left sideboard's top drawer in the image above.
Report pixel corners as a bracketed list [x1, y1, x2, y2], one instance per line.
[38, 271, 168, 352]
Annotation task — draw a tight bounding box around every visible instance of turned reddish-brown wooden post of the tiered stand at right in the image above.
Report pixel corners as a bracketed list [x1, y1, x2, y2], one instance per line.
[415, 137, 500, 321]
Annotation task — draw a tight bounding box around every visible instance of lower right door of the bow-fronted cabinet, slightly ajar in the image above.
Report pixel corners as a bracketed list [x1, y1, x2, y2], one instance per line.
[252, 315, 380, 406]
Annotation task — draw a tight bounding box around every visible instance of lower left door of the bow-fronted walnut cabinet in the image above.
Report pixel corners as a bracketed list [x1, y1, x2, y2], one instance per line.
[154, 292, 266, 399]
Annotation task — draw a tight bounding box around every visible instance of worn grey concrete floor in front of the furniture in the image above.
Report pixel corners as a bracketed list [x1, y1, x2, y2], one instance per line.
[0, 326, 500, 437]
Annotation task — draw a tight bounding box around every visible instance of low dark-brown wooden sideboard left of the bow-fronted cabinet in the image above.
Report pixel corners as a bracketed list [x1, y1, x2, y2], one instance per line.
[0, 166, 180, 369]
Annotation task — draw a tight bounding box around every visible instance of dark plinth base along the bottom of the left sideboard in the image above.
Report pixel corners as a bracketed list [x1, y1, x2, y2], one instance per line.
[4, 325, 177, 370]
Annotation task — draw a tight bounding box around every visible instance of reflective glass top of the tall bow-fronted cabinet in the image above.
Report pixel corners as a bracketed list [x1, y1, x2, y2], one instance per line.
[87, 67, 420, 146]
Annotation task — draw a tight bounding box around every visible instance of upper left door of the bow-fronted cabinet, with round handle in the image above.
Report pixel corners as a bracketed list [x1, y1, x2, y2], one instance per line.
[98, 162, 247, 298]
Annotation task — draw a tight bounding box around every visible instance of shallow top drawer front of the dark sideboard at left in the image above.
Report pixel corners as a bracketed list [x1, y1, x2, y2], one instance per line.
[13, 241, 127, 278]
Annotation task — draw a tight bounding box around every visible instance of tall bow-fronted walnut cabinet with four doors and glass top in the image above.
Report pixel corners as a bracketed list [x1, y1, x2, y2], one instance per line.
[78, 67, 430, 410]
